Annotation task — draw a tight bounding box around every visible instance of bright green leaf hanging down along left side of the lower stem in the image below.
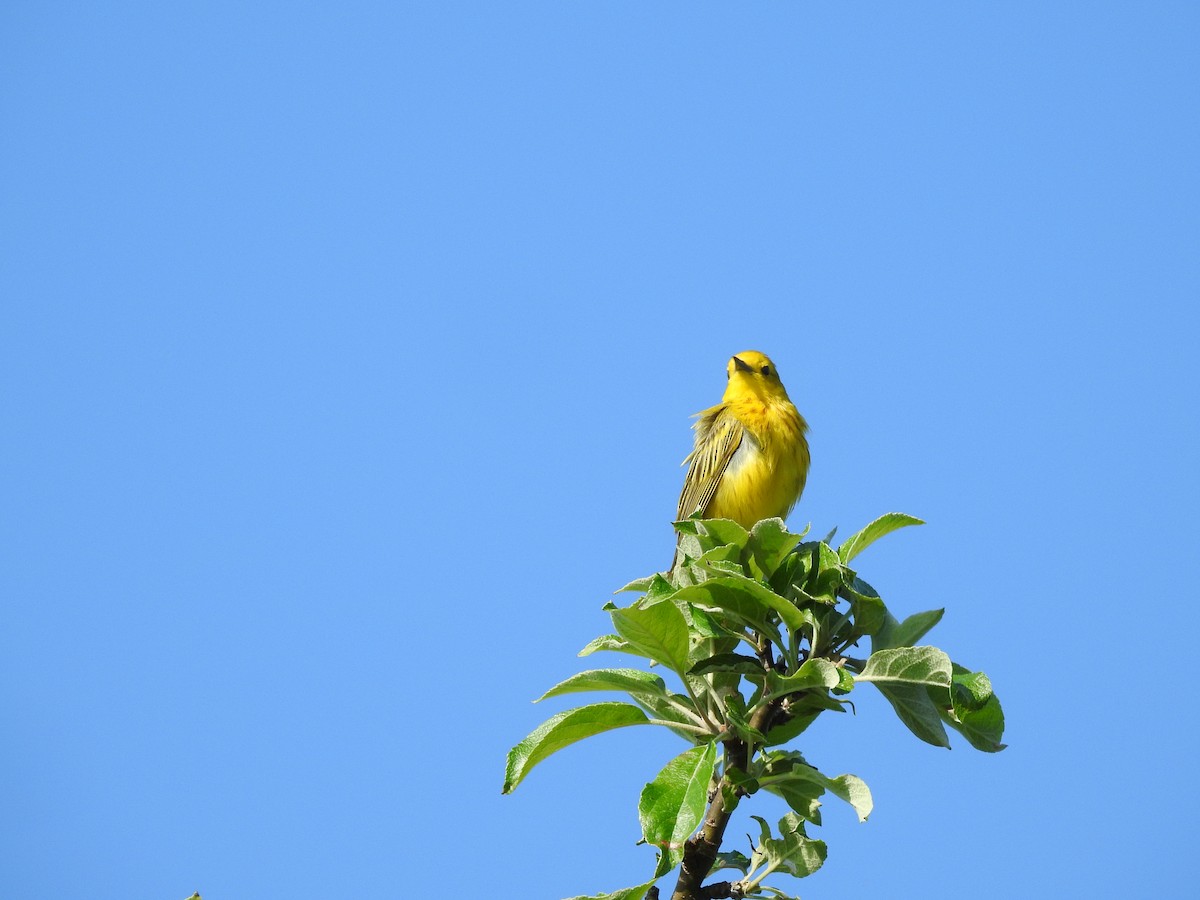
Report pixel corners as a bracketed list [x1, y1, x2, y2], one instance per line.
[637, 743, 716, 877]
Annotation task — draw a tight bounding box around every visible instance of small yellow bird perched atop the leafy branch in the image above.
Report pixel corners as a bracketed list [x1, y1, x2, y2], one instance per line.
[672, 350, 810, 569]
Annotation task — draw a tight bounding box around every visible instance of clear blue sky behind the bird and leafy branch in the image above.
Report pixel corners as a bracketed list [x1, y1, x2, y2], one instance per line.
[0, 1, 1200, 900]
